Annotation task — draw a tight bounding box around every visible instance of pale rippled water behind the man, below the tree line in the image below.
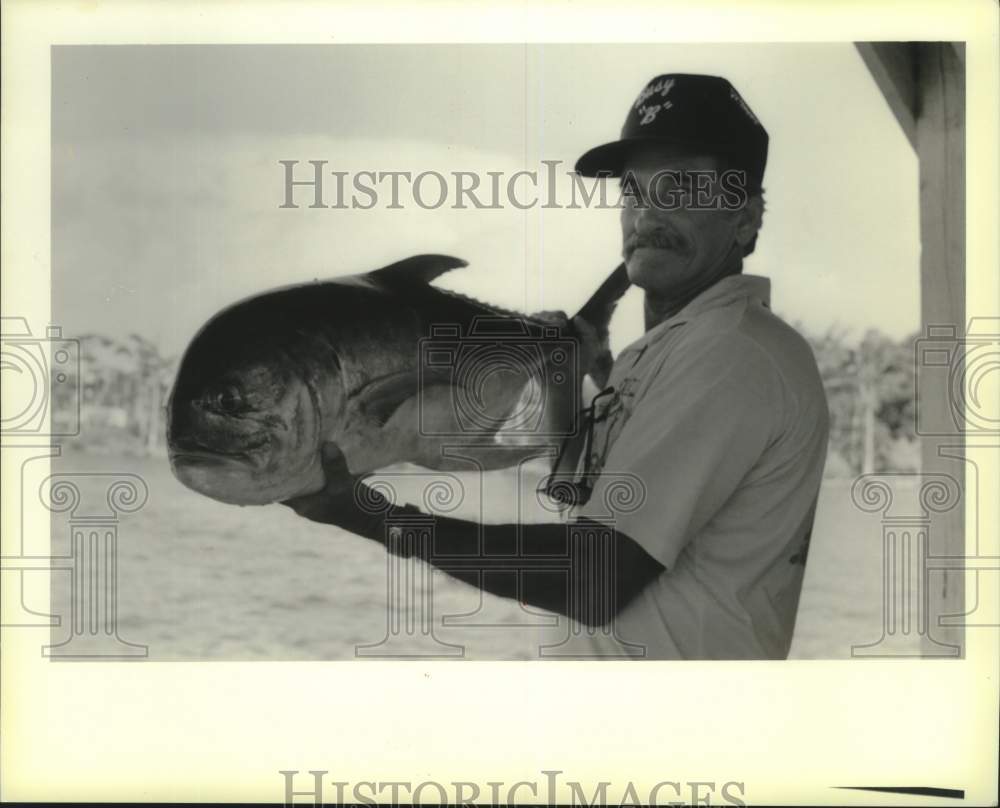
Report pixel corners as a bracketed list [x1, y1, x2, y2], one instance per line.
[45, 452, 919, 660]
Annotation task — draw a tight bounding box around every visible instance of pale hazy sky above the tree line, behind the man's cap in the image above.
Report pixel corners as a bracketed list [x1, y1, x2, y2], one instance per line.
[52, 43, 920, 355]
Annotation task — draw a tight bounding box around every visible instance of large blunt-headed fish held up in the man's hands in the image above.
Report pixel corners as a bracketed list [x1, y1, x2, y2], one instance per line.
[167, 255, 628, 505]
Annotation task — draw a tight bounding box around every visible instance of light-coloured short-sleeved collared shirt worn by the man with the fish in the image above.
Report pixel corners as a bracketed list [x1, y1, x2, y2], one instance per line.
[570, 275, 829, 659]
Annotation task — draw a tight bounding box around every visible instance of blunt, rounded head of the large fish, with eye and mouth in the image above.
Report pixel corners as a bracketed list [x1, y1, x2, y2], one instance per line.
[167, 322, 323, 505]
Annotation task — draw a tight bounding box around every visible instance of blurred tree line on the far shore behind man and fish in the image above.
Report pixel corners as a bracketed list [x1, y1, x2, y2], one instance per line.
[53, 326, 920, 476]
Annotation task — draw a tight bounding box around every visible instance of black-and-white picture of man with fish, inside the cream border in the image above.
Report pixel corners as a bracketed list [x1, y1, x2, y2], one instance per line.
[41, 43, 964, 659]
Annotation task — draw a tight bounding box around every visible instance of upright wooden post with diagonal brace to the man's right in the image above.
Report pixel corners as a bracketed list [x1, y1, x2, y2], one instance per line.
[856, 42, 966, 653]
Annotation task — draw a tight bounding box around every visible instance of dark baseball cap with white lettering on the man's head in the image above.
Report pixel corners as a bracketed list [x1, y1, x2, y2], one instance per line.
[576, 73, 768, 190]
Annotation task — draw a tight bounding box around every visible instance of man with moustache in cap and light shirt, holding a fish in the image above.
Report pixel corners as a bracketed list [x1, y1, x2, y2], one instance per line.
[288, 74, 828, 659]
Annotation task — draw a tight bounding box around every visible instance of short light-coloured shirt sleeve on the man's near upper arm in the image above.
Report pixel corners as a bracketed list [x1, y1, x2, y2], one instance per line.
[578, 336, 781, 569]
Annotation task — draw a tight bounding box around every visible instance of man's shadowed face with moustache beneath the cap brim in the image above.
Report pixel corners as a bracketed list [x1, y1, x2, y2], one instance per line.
[620, 146, 742, 297]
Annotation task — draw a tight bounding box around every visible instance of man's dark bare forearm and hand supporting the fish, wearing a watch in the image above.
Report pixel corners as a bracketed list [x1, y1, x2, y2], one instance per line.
[283, 449, 664, 626]
